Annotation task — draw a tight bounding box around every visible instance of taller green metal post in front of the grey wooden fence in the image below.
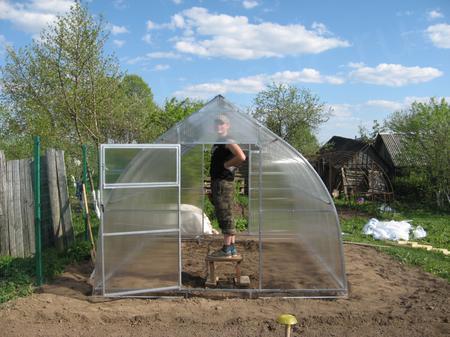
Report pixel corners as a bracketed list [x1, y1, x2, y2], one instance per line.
[34, 136, 43, 286]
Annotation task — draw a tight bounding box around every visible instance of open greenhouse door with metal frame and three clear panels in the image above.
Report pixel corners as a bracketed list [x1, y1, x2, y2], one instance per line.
[97, 144, 181, 296]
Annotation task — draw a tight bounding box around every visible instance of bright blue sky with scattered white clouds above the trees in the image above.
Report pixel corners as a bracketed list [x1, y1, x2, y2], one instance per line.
[0, 0, 450, 142]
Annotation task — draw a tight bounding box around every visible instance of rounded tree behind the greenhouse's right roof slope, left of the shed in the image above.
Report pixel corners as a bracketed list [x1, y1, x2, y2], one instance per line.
[253, 83, 329, 154]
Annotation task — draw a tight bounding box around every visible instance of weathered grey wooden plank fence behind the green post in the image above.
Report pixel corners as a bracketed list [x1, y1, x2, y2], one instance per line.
[0, 149, 73, 257]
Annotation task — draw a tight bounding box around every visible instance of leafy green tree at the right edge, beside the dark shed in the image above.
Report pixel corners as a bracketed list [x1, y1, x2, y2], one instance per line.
[386, 98, 450, 208]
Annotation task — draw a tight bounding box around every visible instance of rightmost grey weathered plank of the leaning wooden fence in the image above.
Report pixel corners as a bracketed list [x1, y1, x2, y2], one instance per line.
[56, 150, 74, 247]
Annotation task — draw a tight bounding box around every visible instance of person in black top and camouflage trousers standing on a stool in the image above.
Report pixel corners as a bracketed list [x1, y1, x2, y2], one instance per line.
[210, 114, 245, 257]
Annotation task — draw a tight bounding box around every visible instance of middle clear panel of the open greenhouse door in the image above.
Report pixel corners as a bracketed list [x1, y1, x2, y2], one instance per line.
[103, 187, 178, 233]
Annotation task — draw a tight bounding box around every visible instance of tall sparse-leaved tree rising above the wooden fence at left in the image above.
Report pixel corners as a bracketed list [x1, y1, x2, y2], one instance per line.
[1, 2, 122, 155]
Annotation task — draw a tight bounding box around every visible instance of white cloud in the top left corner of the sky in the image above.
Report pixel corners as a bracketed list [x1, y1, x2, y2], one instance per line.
[0, 0, 73, 34]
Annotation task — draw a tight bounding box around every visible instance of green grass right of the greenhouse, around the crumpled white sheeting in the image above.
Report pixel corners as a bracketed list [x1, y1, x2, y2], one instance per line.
[336, 200, 450, 283]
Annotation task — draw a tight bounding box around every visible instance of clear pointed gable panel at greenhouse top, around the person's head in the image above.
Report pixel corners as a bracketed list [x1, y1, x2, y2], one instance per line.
[156, 96, 258, 144]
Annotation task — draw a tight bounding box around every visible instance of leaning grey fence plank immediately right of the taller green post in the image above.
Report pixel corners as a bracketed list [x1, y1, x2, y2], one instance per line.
[46, 149, 64, 251]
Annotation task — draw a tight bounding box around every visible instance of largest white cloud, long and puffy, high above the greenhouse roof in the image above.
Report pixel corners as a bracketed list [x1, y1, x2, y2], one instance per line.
[156, 7, 350, 60]
